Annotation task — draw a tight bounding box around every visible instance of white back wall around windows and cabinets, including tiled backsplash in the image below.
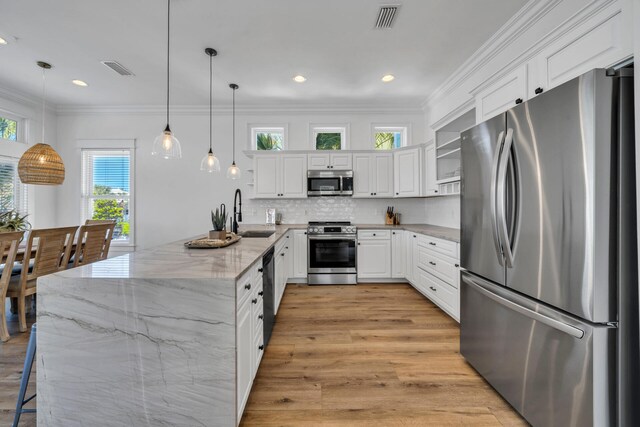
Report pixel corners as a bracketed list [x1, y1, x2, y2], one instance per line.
[57, 111, 436, 248]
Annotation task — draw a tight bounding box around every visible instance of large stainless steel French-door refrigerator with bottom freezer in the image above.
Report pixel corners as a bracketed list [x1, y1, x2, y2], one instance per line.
[460, 69, 640, 426]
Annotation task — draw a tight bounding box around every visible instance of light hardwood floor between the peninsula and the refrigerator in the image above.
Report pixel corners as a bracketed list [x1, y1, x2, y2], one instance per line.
[241, 284, 527, 427]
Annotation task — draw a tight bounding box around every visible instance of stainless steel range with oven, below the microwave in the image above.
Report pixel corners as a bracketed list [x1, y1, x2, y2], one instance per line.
[307, 221, 357, 285]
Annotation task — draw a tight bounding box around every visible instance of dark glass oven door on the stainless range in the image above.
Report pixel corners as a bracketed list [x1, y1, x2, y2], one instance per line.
[307, 235, 356, 274]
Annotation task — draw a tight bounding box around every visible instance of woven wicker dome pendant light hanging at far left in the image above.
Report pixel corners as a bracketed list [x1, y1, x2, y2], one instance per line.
[18, 61, 64, 185]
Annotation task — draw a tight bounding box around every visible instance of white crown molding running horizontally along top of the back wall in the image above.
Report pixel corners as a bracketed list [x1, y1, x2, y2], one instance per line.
[56, 104, 423, 116]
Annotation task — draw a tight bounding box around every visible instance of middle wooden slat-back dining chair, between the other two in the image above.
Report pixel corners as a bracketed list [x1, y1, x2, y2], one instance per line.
[7, 226, 78, 332]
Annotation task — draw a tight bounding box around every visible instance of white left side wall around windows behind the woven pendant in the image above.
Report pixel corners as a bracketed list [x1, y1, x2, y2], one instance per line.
[0, 90, 58, 228]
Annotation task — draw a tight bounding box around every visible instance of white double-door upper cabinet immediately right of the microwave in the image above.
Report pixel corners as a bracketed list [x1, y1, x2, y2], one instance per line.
[353, 153, 393, 198]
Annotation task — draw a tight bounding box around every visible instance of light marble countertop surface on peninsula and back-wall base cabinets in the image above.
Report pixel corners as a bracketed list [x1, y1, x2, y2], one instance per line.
[57, 224, 460, 281]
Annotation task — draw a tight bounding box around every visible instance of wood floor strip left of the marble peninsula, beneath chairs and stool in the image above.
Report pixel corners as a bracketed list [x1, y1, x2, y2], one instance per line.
[0, 300, 37, 427]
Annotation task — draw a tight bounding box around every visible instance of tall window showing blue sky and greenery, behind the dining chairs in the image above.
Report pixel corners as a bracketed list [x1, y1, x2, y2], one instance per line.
[82, 149, 133, 244]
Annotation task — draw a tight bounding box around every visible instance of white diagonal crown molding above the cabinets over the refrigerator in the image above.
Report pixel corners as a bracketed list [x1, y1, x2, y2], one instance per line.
[421, 0, 562, 110]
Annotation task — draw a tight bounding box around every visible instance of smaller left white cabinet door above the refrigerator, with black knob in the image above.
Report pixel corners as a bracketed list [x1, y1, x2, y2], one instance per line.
[476, 64, 527, 123]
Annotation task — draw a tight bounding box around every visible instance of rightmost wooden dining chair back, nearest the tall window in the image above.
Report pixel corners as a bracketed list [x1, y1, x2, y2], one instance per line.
[73, 220, 116, 267]
